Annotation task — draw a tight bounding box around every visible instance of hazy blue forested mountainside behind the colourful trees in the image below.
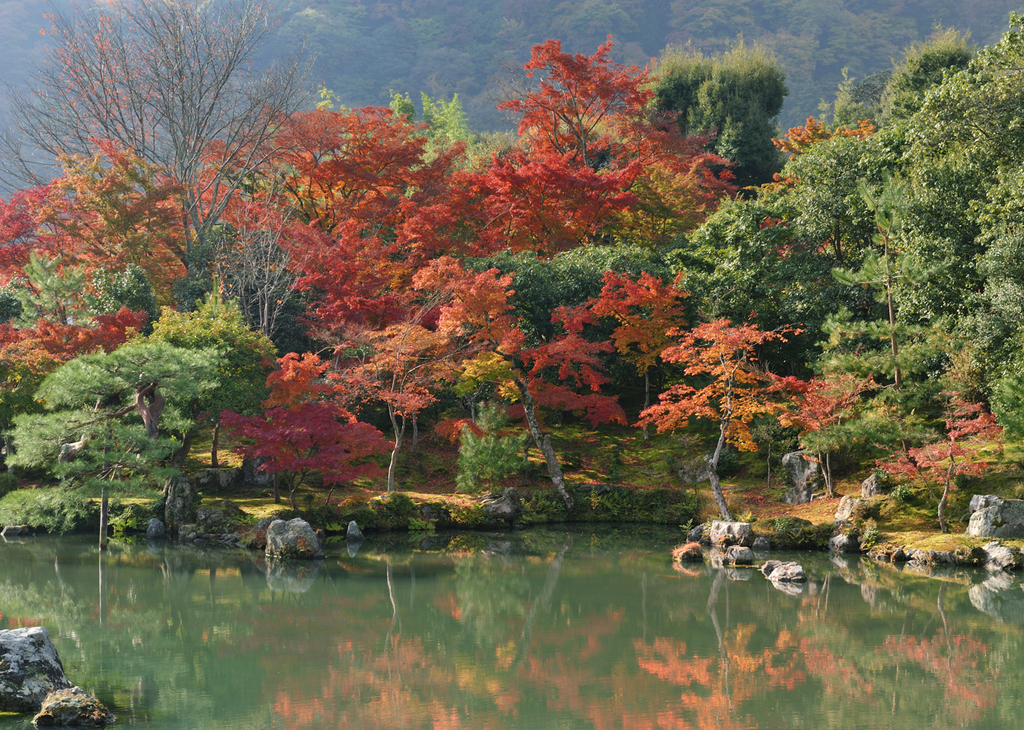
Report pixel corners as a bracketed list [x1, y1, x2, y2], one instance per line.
[6, 0, 1018, 130]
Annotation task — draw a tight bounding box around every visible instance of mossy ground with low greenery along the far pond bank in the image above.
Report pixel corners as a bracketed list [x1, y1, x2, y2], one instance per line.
[0, 415, 1024, 550]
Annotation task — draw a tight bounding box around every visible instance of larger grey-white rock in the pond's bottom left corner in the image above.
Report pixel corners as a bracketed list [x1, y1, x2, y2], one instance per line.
[0, 627, 71, 713]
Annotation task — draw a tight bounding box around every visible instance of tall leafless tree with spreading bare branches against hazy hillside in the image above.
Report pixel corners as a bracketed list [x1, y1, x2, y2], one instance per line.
[5, 0, 308, 272]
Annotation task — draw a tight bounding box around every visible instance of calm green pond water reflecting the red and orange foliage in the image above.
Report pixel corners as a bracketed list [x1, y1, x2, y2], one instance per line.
[0, 528, 1024, 730]
